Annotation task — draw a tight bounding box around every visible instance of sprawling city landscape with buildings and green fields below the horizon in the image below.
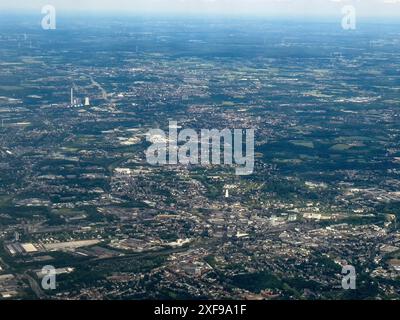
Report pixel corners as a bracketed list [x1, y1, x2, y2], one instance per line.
[0, 0, 400, 300]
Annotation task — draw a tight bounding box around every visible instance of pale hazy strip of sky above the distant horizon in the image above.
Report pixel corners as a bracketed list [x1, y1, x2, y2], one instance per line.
[0, 0, 400, 17]
